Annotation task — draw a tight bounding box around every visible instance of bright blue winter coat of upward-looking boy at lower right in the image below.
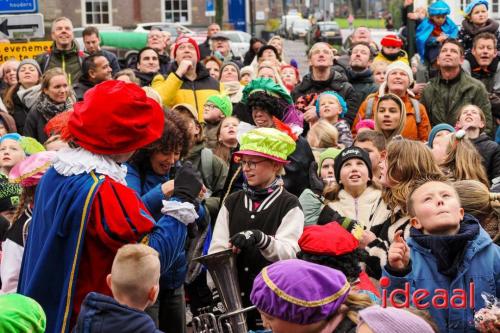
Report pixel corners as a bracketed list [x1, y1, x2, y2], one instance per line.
[383, 215, 500, 333]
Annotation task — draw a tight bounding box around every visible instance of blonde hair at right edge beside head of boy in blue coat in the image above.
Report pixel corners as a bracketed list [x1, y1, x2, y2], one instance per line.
[453, 179, 500, 242]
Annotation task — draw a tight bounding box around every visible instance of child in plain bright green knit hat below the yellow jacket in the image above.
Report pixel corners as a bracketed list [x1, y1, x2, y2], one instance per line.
[203, 95, 233, 149]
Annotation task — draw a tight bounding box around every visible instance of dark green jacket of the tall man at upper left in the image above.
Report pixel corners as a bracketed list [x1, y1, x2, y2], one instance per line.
[36, 41, 85, 86]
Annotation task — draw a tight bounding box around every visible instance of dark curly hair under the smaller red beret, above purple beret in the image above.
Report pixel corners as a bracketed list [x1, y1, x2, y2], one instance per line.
[297, 249, 363, 282]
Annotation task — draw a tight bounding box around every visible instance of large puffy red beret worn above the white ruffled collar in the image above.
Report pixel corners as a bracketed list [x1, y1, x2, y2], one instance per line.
[68, 80, 165, 155]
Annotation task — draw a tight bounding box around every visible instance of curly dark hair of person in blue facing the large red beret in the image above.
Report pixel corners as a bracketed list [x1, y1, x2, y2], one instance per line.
[129, 112, 189, 182]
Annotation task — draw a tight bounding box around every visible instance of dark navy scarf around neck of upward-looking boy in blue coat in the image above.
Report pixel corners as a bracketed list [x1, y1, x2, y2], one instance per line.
[410, 215, 479, 278]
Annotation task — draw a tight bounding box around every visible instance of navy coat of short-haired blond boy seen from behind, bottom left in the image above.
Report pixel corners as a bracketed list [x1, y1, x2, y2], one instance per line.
[73, 292, 161, 333]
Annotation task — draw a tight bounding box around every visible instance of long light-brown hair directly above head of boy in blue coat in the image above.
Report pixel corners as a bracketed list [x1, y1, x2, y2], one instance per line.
[440, 133, 490, 187]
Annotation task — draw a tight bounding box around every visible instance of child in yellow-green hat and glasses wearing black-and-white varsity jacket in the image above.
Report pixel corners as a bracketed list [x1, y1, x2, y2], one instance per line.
[208, 128, 304, 329]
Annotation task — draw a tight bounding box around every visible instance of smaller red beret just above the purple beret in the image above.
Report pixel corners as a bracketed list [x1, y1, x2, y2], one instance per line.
[299, 222, 359, 256]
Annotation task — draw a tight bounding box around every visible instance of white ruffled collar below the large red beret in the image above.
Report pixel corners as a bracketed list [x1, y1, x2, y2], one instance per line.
[54, 148, 127, 185]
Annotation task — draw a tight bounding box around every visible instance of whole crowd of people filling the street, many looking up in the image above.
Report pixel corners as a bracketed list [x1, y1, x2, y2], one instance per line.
[0, 0, 500, 333]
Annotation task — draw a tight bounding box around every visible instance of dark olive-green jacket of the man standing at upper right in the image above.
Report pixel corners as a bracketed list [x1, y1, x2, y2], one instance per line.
[420, 71, 493, 136]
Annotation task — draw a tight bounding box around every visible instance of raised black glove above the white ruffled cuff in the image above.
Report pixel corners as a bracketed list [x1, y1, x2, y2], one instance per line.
[173, 161, 203, 210]
